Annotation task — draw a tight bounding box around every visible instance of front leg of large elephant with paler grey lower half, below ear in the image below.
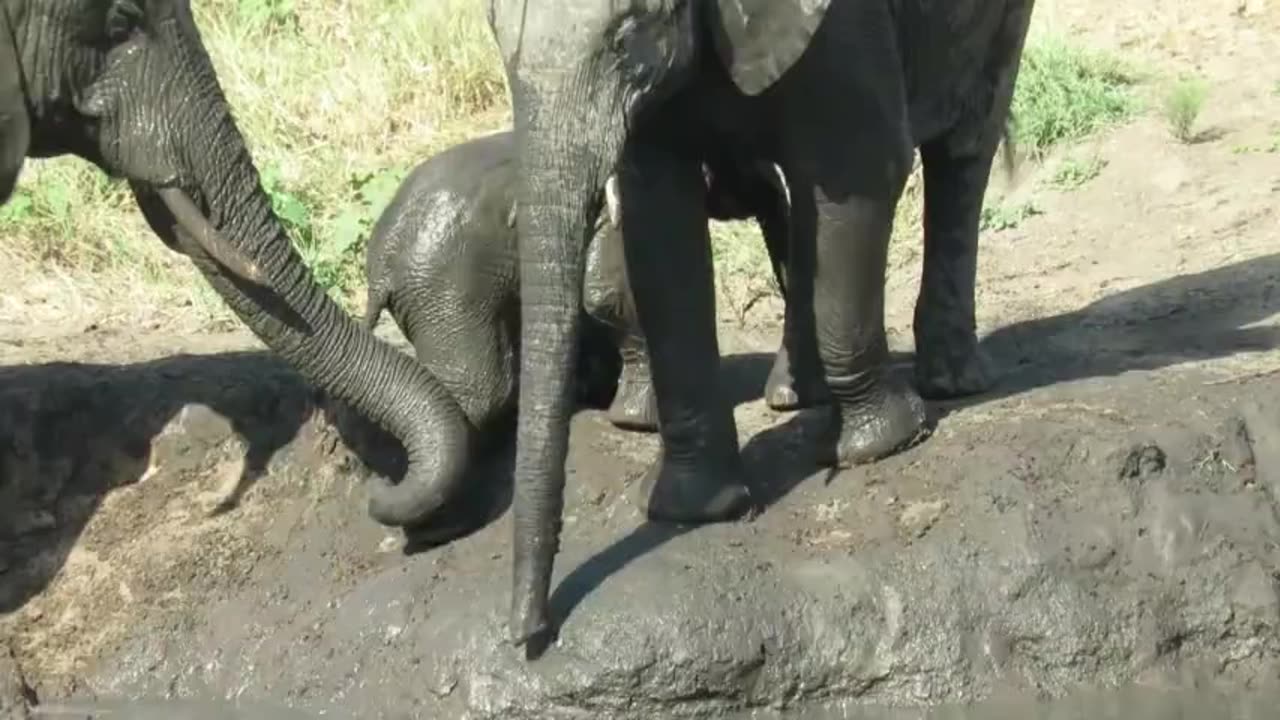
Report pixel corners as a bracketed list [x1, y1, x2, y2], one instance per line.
[778, 3, 928, 466]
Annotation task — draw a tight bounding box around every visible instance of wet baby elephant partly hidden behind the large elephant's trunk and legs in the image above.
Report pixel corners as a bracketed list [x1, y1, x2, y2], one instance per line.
[365, 132, 796, 445]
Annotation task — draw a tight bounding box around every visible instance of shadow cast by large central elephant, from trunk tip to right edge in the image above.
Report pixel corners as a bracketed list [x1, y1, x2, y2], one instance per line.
[537, 254, 1280, 645]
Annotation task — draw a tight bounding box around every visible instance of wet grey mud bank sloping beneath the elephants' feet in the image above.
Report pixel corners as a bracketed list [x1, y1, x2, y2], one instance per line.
[0, 333, 1280, 717]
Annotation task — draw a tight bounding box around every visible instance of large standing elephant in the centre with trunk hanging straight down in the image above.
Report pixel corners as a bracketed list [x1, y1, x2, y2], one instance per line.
[489, 0, 1033, 655]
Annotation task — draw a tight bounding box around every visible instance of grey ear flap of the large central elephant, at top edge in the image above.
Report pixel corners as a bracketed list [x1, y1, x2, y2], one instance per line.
[712, 0, 831, 95]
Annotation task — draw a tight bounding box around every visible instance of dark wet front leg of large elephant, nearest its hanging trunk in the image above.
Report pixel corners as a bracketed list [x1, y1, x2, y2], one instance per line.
[618, 136, 751, 523]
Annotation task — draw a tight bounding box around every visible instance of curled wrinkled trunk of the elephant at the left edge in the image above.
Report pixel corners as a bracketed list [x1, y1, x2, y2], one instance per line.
[172, 98, 470, 525]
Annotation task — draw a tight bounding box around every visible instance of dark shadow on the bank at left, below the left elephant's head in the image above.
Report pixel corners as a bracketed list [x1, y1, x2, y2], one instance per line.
[0, 351, 366, 614]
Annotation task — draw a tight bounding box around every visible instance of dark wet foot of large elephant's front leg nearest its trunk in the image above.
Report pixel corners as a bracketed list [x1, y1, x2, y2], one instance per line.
[640, 456, 755, 525]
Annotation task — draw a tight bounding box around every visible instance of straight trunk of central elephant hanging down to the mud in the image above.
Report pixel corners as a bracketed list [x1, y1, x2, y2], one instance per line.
[508, 99, 622, 644]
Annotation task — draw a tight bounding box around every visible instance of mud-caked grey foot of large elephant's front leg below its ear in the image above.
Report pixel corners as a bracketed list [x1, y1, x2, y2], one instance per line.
[828, 375, 931, 468]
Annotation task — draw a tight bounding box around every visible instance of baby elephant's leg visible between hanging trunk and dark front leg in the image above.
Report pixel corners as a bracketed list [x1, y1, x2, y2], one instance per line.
[582, 192, 658, 433]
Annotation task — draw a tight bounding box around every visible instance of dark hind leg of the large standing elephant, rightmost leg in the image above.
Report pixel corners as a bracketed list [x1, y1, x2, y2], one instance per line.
[914, 140, 995, 398]
